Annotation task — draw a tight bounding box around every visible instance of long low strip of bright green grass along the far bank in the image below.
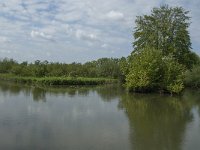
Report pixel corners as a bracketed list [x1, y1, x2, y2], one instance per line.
[0, 74, 118, 86]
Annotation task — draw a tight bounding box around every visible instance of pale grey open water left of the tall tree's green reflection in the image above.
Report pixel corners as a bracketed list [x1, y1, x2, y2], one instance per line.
[0, 83, 130, 150]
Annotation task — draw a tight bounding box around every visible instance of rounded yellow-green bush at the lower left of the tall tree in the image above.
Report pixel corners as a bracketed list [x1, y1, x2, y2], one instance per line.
[126, 48, 162, 91]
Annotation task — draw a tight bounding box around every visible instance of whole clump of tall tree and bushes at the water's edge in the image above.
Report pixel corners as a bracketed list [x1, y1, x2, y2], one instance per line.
[121, 5, 199, 93]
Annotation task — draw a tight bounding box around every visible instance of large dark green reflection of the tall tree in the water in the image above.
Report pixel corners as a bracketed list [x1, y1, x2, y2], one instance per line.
[120, 94, 192, 150]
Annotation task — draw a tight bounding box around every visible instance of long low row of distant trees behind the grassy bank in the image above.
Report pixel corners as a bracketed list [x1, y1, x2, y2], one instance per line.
[0, 58, 121, 79]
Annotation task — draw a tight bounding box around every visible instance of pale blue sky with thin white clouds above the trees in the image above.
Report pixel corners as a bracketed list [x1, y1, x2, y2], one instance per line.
[0, 0, 200, 63]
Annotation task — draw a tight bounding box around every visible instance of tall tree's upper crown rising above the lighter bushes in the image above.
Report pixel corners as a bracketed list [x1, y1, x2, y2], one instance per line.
[133, 5, 195, 68]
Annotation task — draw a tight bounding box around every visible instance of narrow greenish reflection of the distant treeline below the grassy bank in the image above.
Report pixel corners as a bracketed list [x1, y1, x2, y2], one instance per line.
[0, 81, 122, 102]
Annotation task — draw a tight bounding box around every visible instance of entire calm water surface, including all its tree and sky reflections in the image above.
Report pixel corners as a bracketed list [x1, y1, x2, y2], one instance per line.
[0, 82, 200, 150]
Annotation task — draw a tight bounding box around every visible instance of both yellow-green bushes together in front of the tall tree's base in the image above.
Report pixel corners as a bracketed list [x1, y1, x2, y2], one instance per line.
[126, 48, 185, 93]
